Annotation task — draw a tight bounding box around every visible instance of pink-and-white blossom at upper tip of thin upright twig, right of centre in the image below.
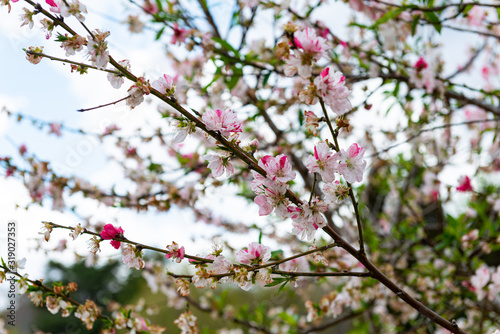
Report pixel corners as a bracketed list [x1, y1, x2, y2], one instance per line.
[314, 66, 352, 115]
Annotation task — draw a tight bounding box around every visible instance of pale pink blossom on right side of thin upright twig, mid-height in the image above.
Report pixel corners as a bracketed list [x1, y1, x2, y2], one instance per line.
[338, 143, 366, 183]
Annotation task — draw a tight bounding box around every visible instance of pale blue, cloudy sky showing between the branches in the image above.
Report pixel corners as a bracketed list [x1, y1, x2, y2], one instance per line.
[0, 0, 492, 310]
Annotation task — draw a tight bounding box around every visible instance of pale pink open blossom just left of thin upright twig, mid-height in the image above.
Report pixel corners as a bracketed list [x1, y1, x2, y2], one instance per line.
[306, 141, 338, 182]
